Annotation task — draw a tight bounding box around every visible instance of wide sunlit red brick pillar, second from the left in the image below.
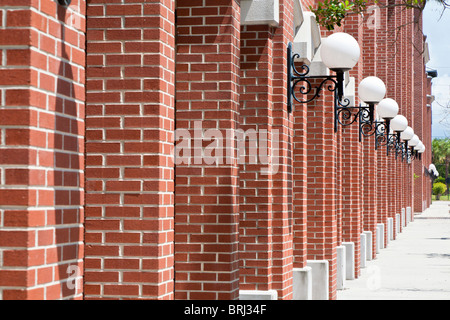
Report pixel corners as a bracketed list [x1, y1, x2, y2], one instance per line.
[85, 0, 175, 299]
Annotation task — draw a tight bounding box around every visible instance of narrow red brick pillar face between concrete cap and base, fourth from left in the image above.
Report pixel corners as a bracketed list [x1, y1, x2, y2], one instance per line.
[239, 25, 278, 290]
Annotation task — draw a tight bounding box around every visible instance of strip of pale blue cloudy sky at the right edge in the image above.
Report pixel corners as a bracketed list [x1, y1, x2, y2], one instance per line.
[423, 1, 450, 138]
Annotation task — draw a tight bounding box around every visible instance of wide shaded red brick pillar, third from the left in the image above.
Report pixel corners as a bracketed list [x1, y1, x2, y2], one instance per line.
[175, 0, 240, 300]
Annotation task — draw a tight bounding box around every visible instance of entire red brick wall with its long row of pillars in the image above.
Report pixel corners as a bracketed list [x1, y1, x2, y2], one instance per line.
[0, 0, 431, 300]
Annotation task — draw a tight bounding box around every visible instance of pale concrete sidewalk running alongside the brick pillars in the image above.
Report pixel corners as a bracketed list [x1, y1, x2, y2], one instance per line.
[337, 201, 450, 300]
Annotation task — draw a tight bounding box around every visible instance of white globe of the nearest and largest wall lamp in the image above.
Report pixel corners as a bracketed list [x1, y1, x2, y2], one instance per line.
[320, 32, 361, 72]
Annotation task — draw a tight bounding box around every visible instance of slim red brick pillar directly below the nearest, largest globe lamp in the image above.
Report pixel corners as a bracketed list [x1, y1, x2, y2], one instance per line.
[307, 76, 337, 299]
